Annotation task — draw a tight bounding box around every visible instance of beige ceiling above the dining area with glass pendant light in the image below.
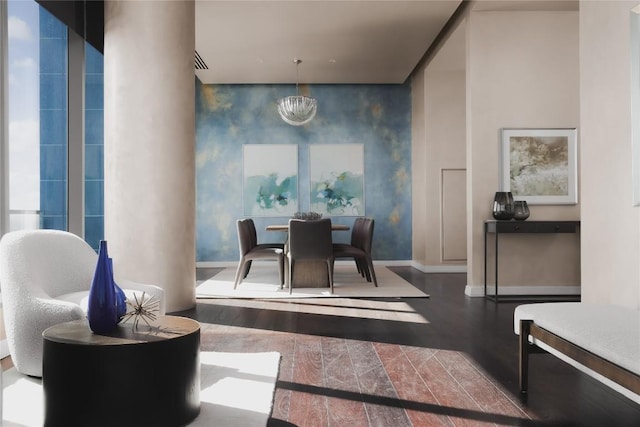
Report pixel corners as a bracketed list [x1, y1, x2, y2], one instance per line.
[196, 0, 461, 84]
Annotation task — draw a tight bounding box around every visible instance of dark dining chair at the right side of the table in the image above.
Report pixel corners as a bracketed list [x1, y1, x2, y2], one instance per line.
[333, 217, 378, 286]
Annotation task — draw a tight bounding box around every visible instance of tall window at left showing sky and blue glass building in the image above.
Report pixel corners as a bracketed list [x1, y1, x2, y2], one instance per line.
[0, 0, 104, 248]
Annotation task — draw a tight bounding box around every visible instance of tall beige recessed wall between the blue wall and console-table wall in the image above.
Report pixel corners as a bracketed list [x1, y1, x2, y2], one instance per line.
[411, 23, 466, 269]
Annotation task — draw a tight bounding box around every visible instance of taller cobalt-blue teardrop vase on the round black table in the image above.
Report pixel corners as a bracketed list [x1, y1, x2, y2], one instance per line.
[87, 240, 119, 334]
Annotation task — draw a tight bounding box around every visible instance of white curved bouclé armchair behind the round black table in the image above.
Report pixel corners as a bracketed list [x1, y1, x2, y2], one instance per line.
[0, 230, 165, 377]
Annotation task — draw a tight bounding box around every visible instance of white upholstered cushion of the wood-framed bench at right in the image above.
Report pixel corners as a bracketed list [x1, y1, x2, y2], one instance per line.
[513, 302, 640, 375]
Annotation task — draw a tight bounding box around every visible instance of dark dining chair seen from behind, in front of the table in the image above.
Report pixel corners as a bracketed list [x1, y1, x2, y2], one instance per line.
[287, 218, 334, 294]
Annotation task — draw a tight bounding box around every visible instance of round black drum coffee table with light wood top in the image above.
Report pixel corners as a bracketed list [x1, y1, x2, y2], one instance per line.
[42, 316, 200, 427]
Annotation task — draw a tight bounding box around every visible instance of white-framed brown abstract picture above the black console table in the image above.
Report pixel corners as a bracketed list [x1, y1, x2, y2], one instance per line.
[500, 128, 578, 205]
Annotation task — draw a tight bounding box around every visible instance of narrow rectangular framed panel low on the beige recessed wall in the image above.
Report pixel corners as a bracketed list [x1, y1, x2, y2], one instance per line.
[440, 169, 467, 261]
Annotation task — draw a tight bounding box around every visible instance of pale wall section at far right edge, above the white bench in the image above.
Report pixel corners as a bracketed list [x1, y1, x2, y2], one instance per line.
[580, 1, 640, 308]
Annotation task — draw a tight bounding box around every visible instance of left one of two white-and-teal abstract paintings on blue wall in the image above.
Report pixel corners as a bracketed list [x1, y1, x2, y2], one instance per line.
[242, 144, 298, 217]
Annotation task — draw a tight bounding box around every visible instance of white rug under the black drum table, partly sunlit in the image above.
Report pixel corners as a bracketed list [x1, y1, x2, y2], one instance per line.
[2, 352, 280, 427]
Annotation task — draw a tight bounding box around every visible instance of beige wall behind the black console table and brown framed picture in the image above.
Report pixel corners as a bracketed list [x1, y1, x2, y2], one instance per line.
[466, 11, 581, 295]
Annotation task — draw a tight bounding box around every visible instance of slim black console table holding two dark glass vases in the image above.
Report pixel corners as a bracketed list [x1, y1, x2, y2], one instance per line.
[484, 220, 580, 302]
